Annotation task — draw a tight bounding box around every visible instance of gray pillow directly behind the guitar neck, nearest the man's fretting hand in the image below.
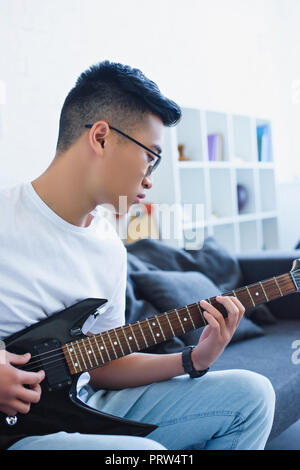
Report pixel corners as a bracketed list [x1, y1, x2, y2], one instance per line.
[131, 270, 264, 344]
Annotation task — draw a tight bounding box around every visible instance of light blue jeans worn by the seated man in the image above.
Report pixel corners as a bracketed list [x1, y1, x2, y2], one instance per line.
[10, 370, 275, 450]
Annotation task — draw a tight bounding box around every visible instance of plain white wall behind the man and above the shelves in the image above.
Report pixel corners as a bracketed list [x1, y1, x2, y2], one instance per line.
[0, 0, 300, 248]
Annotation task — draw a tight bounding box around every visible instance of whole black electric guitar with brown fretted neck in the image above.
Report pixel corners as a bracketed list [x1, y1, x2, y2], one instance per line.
[0, 258, 300, 448]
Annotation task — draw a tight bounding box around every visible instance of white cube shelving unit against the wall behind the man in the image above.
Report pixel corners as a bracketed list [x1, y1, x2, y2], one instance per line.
[144, 108, 279, 253]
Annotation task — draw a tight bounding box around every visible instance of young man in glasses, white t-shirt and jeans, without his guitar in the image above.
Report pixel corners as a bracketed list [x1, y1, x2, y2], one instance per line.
[0, 61, 275, 449]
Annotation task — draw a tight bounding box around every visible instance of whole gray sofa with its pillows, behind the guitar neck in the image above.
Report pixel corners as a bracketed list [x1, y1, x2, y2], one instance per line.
[126, 237, 300, 440]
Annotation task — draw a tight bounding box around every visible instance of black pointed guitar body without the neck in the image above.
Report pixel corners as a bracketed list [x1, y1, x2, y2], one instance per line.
[0, 298, 157, 449]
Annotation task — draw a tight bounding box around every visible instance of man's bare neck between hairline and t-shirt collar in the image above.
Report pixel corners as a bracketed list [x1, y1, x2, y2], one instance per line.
[32, 156, 95, 227]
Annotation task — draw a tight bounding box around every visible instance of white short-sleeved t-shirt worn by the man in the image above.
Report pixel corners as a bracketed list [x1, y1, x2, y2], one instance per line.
[0, 182, 127, 386]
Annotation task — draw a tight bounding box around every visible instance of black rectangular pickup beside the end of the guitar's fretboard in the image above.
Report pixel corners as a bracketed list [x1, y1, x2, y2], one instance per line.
[33, 339, 72, 392]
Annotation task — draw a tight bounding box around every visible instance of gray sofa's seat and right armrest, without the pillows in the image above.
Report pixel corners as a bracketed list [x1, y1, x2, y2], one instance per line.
[212, 250, 300, 440]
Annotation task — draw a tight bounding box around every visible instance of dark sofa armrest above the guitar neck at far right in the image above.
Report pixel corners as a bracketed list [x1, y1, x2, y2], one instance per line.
[237, 250, 300, 287]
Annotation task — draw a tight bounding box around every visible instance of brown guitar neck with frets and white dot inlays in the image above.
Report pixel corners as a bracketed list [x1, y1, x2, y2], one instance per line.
[62, 273, 297, 375]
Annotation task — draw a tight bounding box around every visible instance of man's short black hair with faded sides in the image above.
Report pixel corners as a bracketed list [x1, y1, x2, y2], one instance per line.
[56, 60, 181, 153]
